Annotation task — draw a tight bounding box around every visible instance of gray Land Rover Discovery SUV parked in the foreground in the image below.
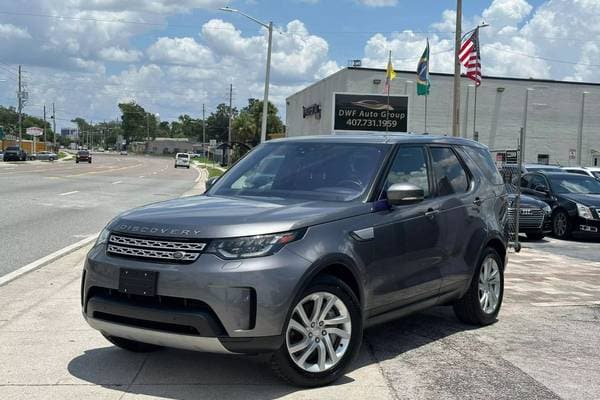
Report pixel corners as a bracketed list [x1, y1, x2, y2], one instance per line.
[81, 134, 507, 386]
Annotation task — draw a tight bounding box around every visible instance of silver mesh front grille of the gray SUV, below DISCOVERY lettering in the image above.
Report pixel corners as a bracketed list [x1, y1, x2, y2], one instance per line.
[106, 234, 206, 263]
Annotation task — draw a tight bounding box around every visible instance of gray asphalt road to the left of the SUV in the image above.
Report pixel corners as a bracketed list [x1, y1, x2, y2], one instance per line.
[0, 154, 198, 276]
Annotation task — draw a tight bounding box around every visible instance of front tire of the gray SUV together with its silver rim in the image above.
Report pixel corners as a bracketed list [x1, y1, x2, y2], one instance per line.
[271, 276, 363, 387]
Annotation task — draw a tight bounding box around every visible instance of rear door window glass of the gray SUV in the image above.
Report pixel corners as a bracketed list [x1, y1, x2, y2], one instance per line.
[431, 147, 469, 196]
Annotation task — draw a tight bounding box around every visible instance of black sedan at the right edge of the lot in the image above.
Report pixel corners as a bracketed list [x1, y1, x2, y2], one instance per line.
[521, 172, 600, 239]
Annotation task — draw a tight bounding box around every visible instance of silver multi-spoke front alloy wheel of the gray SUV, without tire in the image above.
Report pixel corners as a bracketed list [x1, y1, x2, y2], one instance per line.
[286, 292, 352, 372]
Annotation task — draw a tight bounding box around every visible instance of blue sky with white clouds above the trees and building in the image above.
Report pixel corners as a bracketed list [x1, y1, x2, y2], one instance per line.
[0, 0, 600, 128]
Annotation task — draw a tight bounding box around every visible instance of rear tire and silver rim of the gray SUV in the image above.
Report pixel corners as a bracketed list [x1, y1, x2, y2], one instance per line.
[453, 247, 504, 326]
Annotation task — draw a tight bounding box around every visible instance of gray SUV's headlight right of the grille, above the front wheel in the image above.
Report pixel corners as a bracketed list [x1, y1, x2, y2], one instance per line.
[206, 229, 305, 260]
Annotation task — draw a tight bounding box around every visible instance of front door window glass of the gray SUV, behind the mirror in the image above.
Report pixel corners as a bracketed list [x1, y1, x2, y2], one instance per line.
[384, 146, 431, 197]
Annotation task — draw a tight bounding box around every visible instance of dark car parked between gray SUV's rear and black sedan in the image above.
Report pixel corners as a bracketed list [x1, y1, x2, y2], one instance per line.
[508, 194, 552, 240]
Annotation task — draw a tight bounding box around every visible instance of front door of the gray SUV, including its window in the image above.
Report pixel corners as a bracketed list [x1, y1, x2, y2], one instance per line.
[369, 145, 443, 315]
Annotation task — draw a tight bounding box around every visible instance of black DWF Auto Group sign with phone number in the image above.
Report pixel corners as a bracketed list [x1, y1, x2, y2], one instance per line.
[333, 93, 408, 132]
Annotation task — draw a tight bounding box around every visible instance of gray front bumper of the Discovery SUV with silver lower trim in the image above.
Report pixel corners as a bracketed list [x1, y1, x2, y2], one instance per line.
[82, 239, 310, 353]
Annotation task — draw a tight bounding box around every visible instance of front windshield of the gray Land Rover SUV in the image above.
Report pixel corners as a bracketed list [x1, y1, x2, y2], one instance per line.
[210, 142, 391, 201]
